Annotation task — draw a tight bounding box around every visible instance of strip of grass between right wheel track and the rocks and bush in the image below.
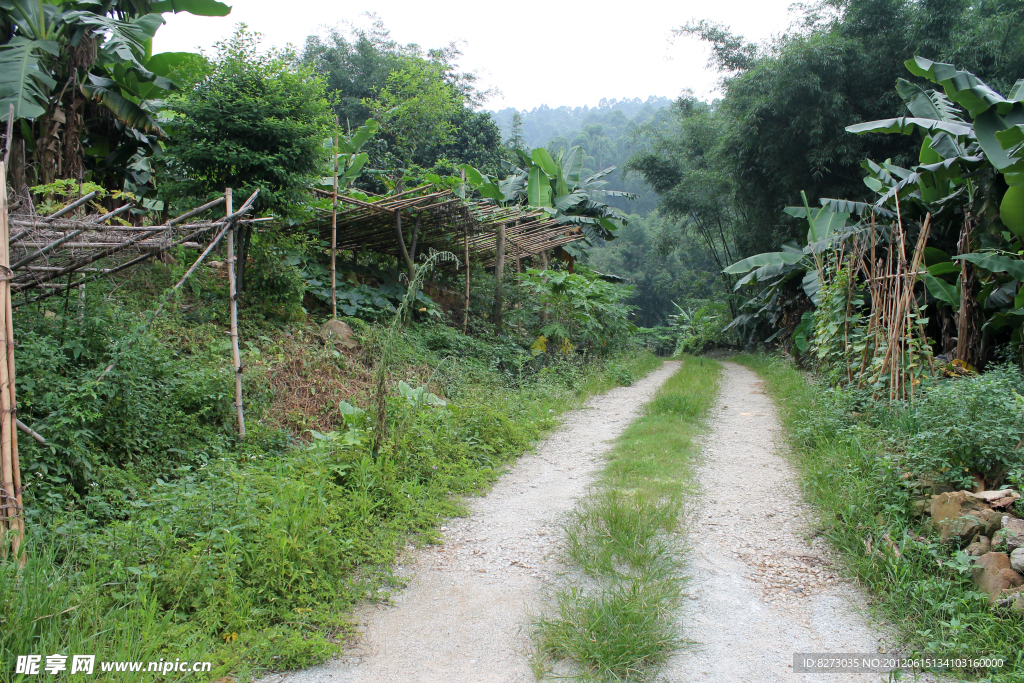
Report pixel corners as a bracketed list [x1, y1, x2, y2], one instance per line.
[733, 354, 1024, 683]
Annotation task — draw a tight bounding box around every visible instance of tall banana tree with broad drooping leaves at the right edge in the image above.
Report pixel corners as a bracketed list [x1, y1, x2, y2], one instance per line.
[847, 57, 1024, 365]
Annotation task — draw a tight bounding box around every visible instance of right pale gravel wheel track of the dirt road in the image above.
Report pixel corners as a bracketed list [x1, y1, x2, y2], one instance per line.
[658, 361, 936, 683]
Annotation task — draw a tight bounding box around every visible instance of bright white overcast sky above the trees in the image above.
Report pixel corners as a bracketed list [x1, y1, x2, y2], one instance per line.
[154, 0, 792, 110]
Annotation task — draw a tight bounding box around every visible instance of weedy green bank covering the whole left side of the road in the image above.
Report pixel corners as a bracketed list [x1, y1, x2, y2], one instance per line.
[0, 259, 656, 681]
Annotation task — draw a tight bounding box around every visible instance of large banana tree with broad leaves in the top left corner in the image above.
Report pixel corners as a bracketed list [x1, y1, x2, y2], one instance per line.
[0, 0, 230, 193]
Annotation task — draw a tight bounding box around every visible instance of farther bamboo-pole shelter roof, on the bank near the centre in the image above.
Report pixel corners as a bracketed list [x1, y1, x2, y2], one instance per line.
[313, 185, 585, 265]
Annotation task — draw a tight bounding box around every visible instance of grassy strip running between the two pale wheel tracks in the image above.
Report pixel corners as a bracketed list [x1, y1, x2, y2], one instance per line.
[535, 356, 721, 681]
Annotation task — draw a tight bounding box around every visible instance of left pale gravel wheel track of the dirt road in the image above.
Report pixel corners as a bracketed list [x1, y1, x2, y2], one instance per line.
[276, 361, 680, 683]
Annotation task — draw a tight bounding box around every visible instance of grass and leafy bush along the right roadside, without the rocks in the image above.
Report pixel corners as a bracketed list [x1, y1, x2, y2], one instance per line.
[737, 355, 1024, 683]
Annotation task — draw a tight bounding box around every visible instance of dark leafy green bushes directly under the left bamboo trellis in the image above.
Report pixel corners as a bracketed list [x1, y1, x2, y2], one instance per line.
[15, 297, 243, 519]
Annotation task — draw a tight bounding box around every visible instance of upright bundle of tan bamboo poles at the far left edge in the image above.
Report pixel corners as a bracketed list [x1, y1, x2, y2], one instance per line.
[0, 156, 25, 564]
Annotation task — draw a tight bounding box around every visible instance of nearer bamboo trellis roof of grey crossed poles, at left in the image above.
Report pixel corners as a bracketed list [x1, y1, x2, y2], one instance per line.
[9, 193, 255, 306]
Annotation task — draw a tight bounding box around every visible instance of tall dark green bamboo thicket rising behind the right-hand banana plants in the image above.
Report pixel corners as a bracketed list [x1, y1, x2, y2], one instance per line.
[680, 0, 1024, 255]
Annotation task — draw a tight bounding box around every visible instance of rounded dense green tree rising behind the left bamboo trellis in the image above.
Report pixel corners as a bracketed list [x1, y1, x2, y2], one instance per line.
[165, 25, 334, 290]
